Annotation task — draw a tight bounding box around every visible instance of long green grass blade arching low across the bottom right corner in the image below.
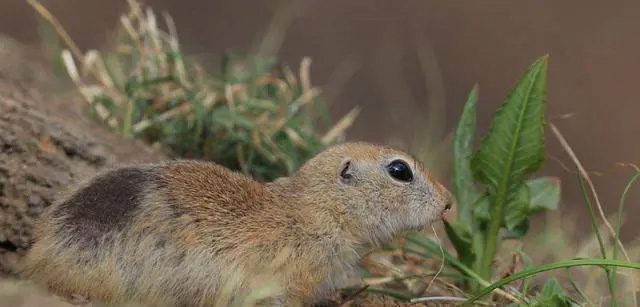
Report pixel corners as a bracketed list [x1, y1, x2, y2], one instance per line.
[463, 259, 640, 306]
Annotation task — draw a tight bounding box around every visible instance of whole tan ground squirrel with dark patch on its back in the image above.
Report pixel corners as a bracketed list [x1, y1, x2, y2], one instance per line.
[22, 143, 451, 306]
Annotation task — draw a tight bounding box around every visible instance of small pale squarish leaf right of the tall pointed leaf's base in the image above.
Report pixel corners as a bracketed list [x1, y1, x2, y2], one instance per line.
[527, 177, 560, 213]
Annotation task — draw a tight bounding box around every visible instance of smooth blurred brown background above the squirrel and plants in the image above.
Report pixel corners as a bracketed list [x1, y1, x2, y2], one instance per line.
[0, 0, 640, 239]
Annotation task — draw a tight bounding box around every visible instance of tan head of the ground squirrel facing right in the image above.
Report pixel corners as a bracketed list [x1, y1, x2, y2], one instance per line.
[287, 143, 452, 244]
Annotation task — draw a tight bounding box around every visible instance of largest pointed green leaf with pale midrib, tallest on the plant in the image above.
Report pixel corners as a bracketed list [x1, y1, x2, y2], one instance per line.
[471, 56, 547, 195]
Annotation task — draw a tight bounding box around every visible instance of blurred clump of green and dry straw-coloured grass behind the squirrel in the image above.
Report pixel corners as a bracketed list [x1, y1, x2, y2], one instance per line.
[29, 0, 358, 180]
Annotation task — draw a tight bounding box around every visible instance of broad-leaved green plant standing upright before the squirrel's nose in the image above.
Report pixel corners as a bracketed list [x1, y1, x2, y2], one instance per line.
[445, 56, 560, 280]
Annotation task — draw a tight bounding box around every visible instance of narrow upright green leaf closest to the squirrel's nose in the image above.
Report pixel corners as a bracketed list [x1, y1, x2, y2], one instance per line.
[453, 85, 480, 225]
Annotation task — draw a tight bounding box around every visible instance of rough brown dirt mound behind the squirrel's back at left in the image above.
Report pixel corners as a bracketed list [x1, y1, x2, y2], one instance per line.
[0, 37, 165, 272]
